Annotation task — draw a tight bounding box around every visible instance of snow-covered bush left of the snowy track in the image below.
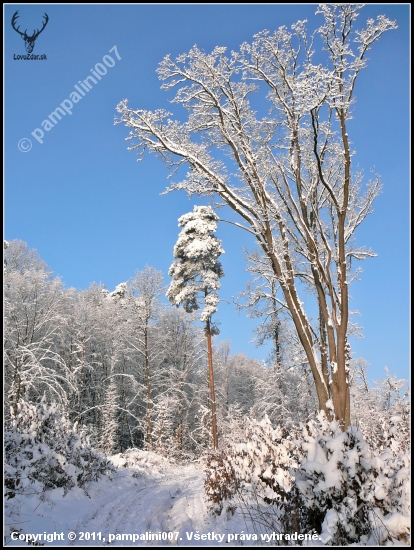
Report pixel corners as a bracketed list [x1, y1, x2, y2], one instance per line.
[4, 400, 115, 498]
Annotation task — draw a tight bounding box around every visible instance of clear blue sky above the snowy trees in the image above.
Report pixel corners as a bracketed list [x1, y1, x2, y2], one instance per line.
[3, 4, 410, 386]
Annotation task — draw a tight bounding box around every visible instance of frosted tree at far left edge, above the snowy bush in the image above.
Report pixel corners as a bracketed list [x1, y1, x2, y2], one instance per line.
[4, 240, 73, 416]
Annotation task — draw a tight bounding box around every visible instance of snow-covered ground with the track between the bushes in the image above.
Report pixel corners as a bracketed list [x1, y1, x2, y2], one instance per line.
[5, 451, 272, 546]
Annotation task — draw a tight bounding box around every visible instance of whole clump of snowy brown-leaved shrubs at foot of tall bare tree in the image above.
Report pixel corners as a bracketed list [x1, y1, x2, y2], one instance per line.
[206, 412, 410, 546]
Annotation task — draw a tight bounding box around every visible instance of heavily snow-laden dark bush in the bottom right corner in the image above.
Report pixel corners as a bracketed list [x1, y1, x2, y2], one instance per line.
[296, 412, 409, 545]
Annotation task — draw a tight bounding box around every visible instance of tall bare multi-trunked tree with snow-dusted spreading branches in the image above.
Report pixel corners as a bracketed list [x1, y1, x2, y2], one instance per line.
[117, 4, 396, 429]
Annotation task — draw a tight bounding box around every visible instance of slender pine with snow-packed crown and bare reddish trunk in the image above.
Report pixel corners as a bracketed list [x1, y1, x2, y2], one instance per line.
[167, 206, 224, 448]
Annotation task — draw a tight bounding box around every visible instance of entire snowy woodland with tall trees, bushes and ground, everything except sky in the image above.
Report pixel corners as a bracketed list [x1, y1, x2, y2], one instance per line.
[4, 4, 410, 546]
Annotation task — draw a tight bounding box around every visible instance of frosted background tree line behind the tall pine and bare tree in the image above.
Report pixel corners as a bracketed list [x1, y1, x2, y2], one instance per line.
[4, 240, 408, 460]
